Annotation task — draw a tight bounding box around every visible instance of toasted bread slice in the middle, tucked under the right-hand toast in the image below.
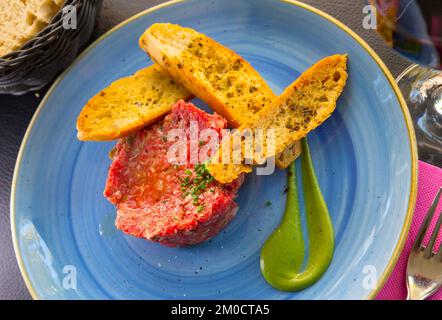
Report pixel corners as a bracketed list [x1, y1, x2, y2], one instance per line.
[139, 23, 300, 168]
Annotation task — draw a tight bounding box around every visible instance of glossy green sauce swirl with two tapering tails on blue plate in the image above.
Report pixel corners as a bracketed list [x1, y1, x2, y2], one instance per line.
[261, 139, 334, 291]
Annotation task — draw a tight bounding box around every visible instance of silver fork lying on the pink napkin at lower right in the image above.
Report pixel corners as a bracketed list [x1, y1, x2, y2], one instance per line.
[407, 188, 442, 300]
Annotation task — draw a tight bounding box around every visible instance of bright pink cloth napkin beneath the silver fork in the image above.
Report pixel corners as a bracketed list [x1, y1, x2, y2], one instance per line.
[376, 161, 442, 300]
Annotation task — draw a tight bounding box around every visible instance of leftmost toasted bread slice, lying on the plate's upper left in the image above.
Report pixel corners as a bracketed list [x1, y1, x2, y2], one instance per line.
[77, 65, 192, 141]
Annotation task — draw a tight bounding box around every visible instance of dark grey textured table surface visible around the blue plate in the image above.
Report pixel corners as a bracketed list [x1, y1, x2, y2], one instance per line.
[0, 0, 410, 299]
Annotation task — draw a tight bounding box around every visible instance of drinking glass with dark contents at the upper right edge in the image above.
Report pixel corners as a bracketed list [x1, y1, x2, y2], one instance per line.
[368, 0, 442, 167]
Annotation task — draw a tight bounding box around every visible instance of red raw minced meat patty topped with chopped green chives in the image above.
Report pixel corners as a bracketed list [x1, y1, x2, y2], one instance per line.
[104, 101, 243, 246]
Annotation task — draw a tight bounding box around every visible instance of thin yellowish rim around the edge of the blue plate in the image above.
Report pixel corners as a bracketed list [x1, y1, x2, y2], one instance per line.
[10, 0, 418, 300]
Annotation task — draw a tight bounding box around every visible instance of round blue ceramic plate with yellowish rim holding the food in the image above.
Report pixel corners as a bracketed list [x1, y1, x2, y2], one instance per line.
[11, 0, 416, 299]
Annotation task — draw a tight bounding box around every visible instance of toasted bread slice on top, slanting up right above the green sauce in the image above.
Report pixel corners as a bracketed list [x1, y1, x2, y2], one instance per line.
[208, 55, 348, 183]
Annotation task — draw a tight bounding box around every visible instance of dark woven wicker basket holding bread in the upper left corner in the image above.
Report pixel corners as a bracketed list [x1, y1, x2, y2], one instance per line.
[0, 0, 102, 95]
